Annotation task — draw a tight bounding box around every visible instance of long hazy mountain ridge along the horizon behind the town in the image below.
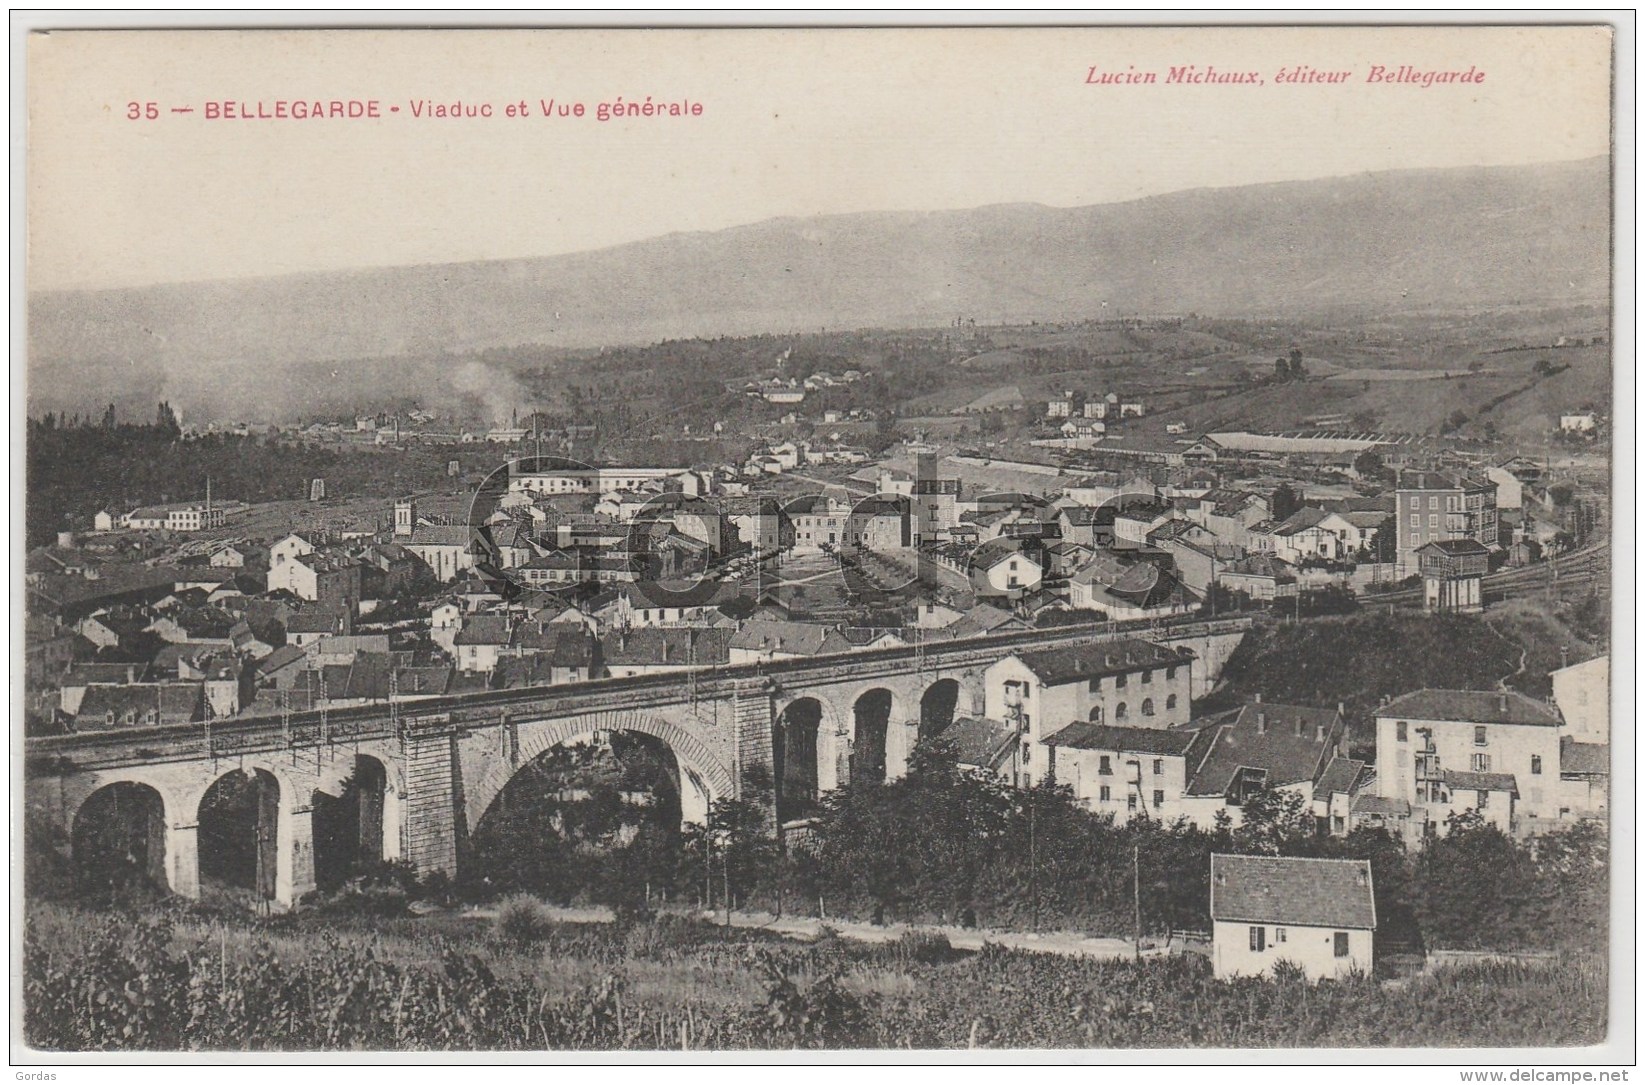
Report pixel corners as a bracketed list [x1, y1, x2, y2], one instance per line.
[28, 159, 1610, 418]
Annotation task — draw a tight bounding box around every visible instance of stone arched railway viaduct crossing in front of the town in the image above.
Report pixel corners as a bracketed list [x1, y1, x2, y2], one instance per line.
[25, 620, 1249, 907]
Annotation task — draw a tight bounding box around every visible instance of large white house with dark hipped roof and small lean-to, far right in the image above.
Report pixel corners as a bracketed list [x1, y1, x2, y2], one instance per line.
[1375, 689, 1563, 833]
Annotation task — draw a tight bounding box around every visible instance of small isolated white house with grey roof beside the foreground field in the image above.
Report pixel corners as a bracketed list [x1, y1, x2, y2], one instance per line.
[1211, 855, 1377, 980]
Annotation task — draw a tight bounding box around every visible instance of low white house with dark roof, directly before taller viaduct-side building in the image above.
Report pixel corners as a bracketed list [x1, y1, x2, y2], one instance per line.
[1045, 723, 1212, 822]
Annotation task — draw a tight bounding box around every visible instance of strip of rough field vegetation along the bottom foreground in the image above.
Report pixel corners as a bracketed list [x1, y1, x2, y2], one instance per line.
[23, 903, 1606, 1050]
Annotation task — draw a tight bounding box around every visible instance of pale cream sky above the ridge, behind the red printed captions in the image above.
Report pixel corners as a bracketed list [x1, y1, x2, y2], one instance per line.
[26, 26, 1610, 289]
